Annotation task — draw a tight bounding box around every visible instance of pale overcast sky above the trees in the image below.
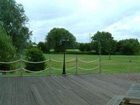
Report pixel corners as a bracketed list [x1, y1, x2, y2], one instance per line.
[16, 0, 140, 42]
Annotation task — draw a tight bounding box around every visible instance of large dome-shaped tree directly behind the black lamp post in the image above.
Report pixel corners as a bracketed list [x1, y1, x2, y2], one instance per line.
[46, 28, 76, 52]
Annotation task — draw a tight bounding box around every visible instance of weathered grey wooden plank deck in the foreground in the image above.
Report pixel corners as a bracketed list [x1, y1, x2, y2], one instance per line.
[0, 74, 140, 105]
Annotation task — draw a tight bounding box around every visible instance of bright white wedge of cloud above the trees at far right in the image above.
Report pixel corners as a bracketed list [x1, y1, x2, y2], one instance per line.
[104, 13, 140, 40]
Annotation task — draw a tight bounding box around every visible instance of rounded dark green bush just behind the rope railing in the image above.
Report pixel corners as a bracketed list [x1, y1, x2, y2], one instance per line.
[26, 48, 45, 71]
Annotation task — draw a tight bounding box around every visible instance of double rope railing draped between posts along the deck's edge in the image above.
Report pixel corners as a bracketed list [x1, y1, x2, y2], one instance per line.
[0, 57, 99, 74]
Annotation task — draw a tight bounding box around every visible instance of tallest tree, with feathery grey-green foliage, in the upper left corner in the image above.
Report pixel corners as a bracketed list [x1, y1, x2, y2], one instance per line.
[0, 0, 31, 52]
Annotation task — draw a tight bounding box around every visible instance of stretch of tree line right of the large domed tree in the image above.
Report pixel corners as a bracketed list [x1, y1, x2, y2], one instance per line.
[79, 31, 140, 55]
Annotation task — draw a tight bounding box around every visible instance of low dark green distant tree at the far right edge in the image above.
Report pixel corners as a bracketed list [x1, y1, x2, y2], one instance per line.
[117, 39, 140, 55]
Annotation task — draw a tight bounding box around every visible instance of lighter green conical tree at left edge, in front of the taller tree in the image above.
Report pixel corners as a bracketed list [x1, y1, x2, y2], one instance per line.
[0, 25, 16, 74]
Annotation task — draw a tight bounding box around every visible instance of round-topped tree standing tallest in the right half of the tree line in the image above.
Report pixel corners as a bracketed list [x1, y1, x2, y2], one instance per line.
[92, 31, 115, 59]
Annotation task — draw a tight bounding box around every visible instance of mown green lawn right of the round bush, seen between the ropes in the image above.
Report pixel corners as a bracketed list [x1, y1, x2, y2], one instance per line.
[45, 54, 140, 73]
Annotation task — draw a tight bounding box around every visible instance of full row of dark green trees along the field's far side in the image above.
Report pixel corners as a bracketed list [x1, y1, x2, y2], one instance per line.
[37, 28, 140, 55]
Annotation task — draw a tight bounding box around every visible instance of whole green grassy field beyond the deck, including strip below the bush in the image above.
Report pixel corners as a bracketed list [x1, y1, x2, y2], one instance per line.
[0, 54, 140, 76]
